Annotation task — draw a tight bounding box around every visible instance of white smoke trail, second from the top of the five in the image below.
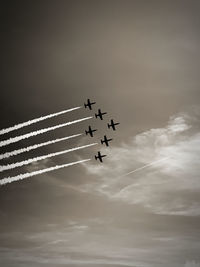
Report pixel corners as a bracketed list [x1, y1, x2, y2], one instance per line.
[0, 116, 93, 147]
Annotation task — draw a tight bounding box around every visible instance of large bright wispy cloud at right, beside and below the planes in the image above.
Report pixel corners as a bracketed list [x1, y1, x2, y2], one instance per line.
[80, 107, 200, 216]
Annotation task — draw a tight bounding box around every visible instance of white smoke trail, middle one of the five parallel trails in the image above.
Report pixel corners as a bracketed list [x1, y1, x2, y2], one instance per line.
[0, 134, 82, 160]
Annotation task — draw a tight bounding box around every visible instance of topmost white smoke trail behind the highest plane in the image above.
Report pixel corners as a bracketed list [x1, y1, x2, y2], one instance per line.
[0, 107, 82, 135]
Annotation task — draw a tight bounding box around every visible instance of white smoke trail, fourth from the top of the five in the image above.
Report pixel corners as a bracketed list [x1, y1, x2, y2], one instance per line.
[0, 143, 98, 172]
